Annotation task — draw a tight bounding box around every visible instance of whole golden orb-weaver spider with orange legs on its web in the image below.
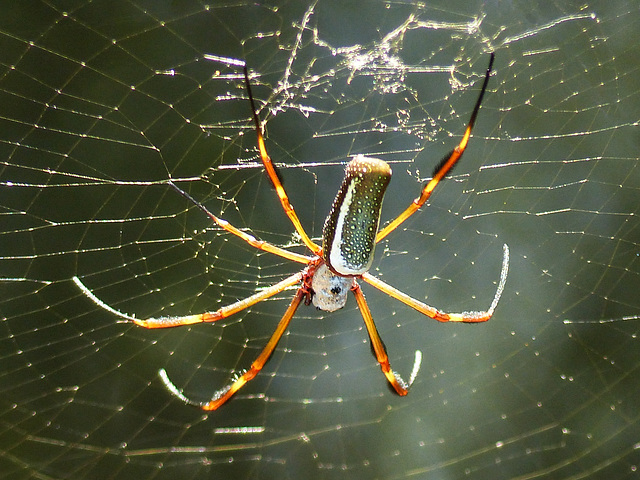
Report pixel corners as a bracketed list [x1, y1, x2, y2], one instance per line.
[73, 53, 509, 410]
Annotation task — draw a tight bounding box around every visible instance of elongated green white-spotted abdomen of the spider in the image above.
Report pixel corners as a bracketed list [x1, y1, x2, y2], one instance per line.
[322, 155, 391, 276]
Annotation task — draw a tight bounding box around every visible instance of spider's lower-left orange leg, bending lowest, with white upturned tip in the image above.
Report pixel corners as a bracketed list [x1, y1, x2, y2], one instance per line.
[160, 287, 306, 410]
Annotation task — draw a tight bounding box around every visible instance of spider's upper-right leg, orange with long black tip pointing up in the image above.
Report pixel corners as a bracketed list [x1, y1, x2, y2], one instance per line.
[376, 52, 494, 243]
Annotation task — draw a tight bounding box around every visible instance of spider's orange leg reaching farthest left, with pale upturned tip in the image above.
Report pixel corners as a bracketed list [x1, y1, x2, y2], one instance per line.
[73, 272, 303, 328]
